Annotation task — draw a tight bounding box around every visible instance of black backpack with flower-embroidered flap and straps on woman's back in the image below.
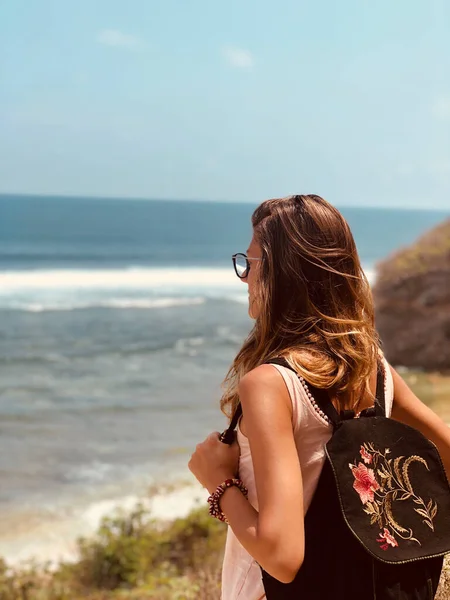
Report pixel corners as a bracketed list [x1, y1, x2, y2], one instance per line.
[223, 358, 450, 600]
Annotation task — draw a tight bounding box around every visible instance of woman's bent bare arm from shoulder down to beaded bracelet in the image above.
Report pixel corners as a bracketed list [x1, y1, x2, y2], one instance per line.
[217, 365, 304, 583]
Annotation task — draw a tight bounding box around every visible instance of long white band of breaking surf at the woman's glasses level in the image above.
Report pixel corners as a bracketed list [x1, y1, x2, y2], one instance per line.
[0, 268, 375, 313]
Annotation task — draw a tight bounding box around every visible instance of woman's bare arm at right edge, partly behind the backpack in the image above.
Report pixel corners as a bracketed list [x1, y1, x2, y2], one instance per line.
[390, 367, 450, 481]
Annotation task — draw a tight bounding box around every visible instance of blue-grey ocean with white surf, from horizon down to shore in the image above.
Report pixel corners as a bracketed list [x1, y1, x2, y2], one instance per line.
[0, 195, 448, 561]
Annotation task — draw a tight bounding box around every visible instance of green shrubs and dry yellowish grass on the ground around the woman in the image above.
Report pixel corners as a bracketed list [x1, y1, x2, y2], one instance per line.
[0, 372, 450, 600]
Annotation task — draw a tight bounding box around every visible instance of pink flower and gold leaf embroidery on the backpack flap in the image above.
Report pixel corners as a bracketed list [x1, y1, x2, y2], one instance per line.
[349, 442, 437, 550]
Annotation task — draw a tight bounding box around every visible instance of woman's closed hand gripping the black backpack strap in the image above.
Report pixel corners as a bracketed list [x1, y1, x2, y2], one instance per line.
[188, 431, 240, 494]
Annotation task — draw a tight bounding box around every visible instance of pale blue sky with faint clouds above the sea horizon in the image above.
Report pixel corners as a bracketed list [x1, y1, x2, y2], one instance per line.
[0, 0, 450, 209]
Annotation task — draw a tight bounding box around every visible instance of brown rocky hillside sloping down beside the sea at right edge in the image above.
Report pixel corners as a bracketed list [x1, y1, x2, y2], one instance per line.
[373, 219, 450, 372]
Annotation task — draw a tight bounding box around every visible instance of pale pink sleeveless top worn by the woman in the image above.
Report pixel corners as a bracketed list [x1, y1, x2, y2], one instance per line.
[221, 359, 394, 600]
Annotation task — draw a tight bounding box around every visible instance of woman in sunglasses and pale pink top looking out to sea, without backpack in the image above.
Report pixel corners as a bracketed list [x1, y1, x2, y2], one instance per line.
[189, 195, 450, 600]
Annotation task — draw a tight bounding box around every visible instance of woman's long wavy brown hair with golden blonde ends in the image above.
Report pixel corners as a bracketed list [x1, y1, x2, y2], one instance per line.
[220, 195, 380, 418]
